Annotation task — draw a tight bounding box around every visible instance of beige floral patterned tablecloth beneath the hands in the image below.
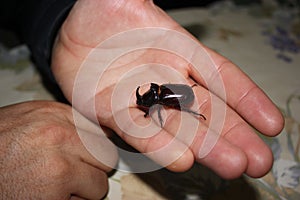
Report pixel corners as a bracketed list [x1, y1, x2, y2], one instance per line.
[0, 1, 300, 200]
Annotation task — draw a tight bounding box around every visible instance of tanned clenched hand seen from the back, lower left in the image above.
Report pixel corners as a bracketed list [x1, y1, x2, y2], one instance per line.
[0, 102, 117, 199]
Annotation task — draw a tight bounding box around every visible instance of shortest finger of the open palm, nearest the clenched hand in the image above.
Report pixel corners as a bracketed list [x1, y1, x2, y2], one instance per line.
[111, 108, 194, 172]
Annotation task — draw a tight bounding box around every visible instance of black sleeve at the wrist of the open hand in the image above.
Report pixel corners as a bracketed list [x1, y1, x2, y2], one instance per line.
[0, 0, 76, 81]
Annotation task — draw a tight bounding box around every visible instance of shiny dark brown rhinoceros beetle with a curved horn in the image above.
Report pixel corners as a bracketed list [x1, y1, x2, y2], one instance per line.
[136, 83, 206, 127]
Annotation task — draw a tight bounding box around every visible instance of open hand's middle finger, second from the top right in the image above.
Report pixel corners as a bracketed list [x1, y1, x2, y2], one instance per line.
[194, 83, 273, 177]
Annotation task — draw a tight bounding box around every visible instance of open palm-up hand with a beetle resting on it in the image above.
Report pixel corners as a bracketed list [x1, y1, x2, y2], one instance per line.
[52, 0, 283, 178]
